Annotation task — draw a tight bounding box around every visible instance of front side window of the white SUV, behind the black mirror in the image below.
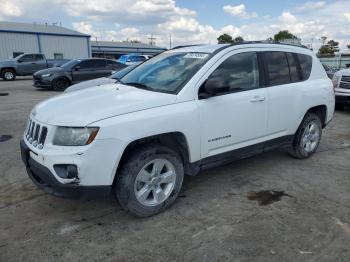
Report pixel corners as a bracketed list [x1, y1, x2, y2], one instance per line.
[209, 52, 259, 93]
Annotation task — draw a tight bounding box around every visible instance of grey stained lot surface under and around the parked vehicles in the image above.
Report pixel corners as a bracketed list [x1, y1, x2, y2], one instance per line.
[0, 78, 350, 262]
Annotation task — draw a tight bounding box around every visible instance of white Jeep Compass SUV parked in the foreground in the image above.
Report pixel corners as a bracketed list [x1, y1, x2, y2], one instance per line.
[21, 42, 334, 217]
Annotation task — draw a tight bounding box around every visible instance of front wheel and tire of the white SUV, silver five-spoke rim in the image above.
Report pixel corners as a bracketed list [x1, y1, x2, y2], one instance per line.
[114, 144, 184, 217]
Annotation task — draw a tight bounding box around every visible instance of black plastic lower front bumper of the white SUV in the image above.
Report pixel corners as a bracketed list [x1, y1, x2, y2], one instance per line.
[20, 139, 112, 199]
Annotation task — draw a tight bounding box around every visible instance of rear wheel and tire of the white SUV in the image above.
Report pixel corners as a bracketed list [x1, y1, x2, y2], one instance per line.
[289, 113, 322, 159]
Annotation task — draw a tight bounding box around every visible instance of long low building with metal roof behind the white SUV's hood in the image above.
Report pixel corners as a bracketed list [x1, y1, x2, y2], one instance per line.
[91, 41, 166, 59]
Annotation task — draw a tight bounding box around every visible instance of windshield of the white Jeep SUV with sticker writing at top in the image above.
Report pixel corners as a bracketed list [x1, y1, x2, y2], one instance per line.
[121, 52, 209, 94]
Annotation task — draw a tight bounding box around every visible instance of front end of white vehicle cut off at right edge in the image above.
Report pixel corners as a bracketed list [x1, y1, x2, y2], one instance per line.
[333, 68, 350, 109]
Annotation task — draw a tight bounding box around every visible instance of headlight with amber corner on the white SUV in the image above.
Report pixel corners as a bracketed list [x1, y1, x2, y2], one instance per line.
[53, 127, 99, 146]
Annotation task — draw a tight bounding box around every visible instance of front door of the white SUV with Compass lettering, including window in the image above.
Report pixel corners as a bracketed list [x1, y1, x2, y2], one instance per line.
[198, 52, 268, 160]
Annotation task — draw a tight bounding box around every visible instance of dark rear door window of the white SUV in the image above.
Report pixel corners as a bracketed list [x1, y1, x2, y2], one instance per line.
[264, 52, 290, 86]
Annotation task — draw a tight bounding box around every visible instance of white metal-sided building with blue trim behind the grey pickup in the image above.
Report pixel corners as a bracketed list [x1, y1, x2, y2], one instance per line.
[0, 21, 91, 59]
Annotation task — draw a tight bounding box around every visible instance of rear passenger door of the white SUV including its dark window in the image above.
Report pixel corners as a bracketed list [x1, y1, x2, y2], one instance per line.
[262, 51, 311, 138]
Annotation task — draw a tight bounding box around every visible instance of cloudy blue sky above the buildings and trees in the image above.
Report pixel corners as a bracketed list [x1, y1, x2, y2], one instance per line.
[0, 0, 350, 50]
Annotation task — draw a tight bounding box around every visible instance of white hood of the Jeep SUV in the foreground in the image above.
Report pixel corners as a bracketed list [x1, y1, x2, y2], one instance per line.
[32, 84, 176, 126]
